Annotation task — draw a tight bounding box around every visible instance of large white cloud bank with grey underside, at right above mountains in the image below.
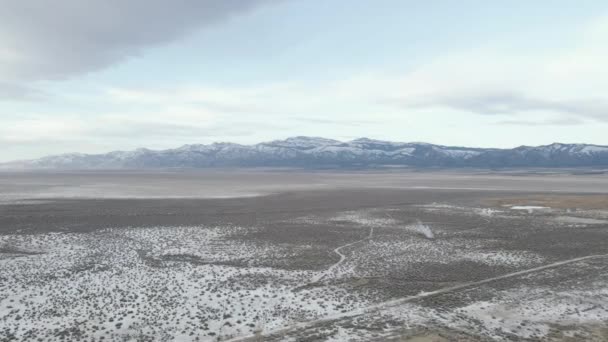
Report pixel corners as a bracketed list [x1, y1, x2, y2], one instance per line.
[376, 16, 608, 122]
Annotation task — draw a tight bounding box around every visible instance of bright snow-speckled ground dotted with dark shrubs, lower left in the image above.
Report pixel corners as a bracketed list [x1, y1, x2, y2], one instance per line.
[0, 226, 367, 341]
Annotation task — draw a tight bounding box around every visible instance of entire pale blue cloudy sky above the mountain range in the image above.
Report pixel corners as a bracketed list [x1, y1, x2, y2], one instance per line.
[0, 0, 608, 161]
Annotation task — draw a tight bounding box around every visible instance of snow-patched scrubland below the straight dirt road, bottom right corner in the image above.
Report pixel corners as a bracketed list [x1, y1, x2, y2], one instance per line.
[255, 256, 608, 342]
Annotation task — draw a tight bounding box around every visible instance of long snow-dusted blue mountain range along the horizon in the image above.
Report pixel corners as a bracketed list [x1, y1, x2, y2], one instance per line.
[4, 137, 608, 169]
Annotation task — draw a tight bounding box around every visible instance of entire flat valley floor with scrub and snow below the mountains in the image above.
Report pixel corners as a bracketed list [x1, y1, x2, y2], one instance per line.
[0, 170, 608, 341]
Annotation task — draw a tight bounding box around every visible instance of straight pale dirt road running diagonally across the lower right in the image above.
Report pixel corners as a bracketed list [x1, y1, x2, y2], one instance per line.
[226, 252, 608, 342]
